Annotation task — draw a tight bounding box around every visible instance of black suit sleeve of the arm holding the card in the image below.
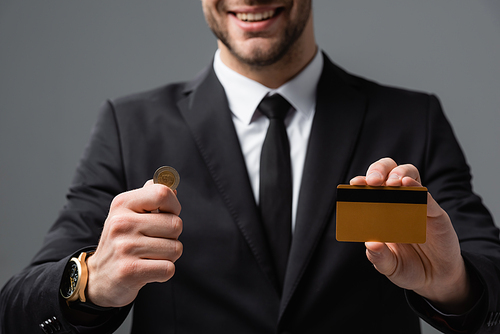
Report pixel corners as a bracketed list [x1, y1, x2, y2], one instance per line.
[408, 96, 500, 333]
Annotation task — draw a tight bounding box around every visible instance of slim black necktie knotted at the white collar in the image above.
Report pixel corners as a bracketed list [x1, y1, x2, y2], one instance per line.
[258, 94, 292, 289]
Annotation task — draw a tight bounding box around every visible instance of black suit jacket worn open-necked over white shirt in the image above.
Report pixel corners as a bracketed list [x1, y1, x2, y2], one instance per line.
[1, 53, 500, 334]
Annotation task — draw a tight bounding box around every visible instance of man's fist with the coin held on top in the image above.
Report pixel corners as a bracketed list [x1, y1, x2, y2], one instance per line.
[87, 181, 182, 307]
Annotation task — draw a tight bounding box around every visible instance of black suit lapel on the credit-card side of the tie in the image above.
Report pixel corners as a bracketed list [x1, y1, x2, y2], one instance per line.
[280, 56, 366, 316]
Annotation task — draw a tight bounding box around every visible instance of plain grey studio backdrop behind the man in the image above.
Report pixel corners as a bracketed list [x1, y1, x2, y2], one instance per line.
[0, 0, 500, 333]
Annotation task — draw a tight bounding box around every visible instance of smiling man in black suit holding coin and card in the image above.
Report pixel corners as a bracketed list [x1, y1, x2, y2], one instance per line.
[1, 0, 500, 333]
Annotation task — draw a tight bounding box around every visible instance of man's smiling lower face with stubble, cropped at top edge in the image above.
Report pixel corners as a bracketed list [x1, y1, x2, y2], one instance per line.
[202, 0, 314, 67]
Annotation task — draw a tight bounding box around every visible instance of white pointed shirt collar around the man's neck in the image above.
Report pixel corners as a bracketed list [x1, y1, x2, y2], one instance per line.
[213, 50, 323, 124]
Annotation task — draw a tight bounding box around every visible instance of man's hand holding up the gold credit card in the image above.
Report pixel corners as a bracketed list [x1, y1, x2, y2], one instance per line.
[350, 158, 475, 314]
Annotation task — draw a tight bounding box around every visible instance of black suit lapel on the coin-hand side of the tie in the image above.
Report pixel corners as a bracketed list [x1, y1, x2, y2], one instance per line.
[178, 66, 276, 292]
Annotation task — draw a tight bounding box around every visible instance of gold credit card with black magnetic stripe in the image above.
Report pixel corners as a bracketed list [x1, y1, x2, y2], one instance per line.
[337, 185, 427, 243]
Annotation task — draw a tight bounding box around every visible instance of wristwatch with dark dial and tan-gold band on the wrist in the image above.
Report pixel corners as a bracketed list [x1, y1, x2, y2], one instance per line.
[60, 252, 94, 305]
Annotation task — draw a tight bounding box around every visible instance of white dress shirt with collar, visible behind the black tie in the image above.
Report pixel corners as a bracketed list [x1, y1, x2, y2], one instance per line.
[214, 50, 323, 231]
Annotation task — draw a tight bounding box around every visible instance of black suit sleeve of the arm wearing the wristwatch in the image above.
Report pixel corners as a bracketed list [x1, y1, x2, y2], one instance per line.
[0, 103, 130, 334]
